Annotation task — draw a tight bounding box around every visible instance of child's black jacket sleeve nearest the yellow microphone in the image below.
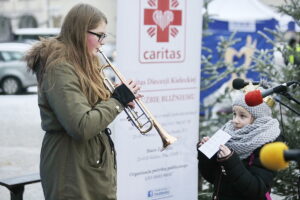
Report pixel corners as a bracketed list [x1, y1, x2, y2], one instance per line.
[220, 153, 276, 199]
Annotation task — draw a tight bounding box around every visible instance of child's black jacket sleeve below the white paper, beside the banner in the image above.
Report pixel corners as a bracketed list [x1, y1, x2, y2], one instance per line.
[198, 151, 218, 184]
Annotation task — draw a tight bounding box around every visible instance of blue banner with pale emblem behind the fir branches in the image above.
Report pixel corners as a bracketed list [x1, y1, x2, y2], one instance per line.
[200, 19, 277, 108]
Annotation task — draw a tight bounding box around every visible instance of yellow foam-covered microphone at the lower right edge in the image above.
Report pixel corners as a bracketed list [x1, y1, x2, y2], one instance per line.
[259, 142, 300, 171]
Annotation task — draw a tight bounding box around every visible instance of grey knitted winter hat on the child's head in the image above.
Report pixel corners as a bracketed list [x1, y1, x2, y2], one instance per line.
[232, 93, 272, 119]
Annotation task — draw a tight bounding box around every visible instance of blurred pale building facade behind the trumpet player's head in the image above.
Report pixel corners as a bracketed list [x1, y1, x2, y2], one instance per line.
[0, 0, 117, 42]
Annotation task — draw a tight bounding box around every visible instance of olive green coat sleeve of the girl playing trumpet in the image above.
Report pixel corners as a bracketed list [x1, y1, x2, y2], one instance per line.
[42, 64, 124, 140]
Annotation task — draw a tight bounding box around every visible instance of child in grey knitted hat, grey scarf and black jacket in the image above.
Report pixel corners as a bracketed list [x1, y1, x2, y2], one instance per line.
[198, 91, 280, 200]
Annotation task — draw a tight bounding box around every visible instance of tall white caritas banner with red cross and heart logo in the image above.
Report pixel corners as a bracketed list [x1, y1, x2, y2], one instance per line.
[113, 0, 202, 200]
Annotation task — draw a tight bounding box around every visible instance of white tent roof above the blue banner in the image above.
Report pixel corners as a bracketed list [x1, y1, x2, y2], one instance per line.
[208, 0, 300, 30]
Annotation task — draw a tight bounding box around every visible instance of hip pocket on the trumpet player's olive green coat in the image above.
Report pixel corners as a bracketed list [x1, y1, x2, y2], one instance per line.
[86, 135, 106, 168]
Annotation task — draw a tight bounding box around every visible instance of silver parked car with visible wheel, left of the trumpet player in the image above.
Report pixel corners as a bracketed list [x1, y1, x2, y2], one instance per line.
[0, 42, 37, 94]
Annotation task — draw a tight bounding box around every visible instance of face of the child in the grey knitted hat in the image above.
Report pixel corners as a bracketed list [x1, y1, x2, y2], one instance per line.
[232, 106, 254, 129]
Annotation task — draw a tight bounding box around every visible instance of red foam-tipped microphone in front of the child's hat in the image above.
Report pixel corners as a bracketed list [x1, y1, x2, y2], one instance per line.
[245, 81, 296, 106]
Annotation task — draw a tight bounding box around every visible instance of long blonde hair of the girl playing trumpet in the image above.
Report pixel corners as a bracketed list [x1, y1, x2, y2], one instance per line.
[57, 4, 110, 105]
